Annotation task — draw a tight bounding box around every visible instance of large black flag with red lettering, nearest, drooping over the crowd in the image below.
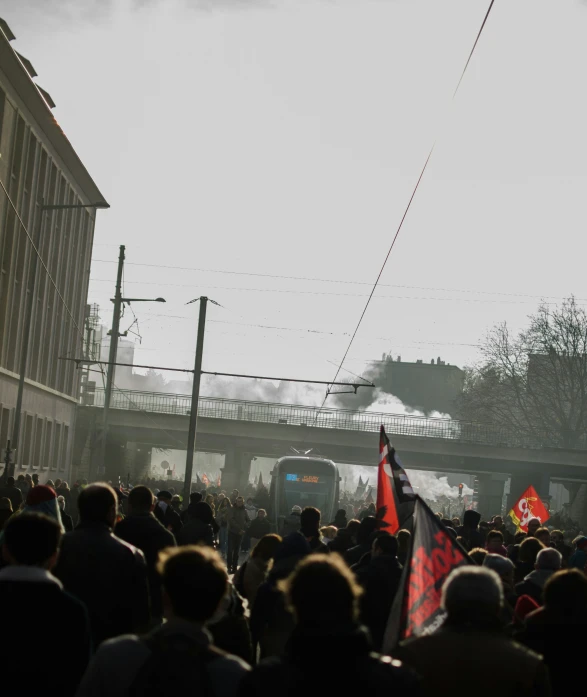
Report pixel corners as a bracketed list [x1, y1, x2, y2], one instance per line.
[383, 496, 472, 653]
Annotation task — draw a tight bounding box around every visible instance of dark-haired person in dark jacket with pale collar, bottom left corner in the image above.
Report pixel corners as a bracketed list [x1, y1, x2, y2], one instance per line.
[0, 513, 92, 697]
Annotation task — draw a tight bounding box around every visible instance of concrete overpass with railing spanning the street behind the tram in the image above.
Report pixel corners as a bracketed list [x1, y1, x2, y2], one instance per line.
[77, 390, 587, 510]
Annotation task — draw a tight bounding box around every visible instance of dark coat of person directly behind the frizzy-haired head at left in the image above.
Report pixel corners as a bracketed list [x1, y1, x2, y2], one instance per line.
[115, 513, 175, 620]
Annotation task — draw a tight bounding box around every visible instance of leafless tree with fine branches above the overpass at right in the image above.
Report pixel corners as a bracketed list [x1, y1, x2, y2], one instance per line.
[461, 297, 587, 448]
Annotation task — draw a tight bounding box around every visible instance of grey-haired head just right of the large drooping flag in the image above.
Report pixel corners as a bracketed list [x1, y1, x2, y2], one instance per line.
[442, 566, 503, 625]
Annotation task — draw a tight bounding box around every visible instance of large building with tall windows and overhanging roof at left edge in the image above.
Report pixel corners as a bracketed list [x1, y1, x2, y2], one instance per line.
[0, 20, 105, 481]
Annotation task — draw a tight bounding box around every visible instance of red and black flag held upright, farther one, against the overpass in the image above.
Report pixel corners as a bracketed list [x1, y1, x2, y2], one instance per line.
[376, 426, 416, 535]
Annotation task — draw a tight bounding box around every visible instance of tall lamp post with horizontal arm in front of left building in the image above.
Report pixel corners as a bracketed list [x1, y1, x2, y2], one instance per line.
[0, 198, 110, 482]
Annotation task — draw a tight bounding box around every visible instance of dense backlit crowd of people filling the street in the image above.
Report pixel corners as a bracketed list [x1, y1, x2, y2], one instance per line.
[0, 478, 587, 697]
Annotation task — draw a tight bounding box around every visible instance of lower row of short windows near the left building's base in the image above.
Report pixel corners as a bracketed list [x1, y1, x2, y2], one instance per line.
[0, 404, 70, 475]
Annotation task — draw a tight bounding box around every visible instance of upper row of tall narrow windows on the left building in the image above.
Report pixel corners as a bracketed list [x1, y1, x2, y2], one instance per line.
[0, 82, 93, 397]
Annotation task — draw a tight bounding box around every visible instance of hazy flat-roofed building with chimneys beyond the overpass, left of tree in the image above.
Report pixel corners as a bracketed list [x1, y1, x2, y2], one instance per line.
[377, 356, 465, 415]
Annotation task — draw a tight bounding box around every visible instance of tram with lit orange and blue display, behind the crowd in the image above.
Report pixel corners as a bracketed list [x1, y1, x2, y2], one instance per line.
[269, 455, 340, 525]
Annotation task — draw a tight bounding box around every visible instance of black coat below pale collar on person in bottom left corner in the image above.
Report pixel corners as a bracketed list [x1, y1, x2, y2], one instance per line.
[0, 580, 92, 697]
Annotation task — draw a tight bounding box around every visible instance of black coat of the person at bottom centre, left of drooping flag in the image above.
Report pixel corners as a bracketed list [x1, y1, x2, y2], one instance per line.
[239, 626, 421, 697]
